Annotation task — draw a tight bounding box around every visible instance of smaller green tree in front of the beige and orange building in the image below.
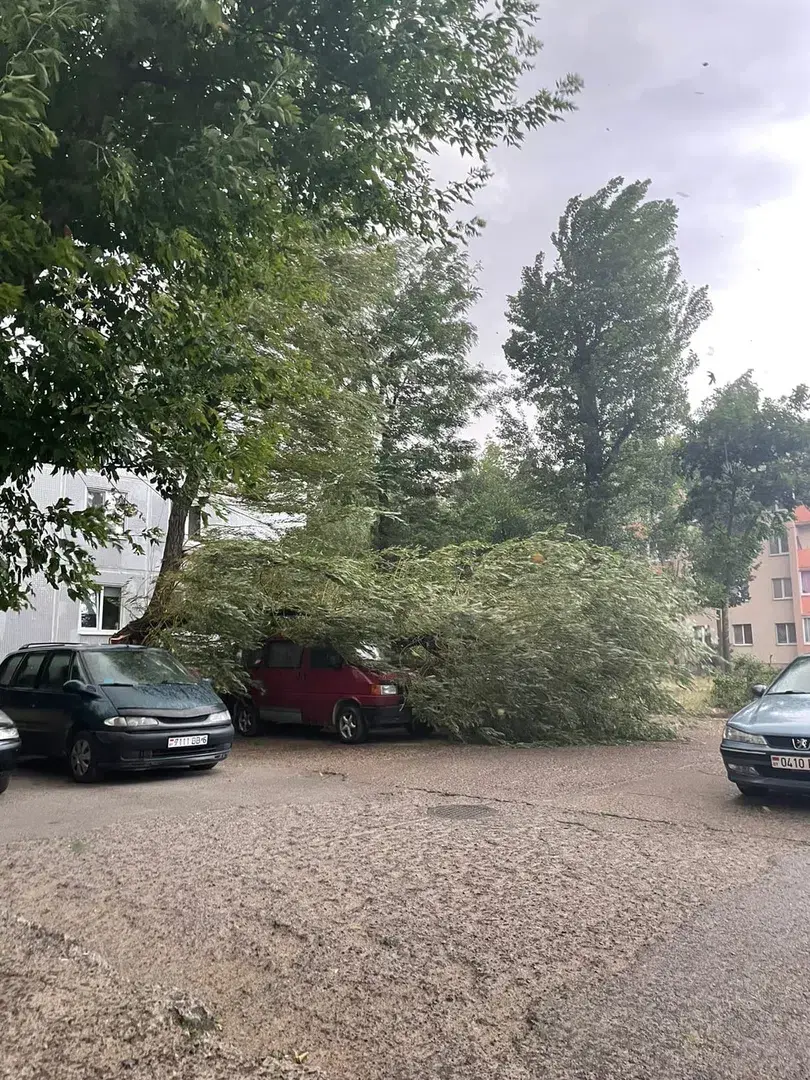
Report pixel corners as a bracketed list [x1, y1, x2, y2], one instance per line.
[681, 372, 810, 622]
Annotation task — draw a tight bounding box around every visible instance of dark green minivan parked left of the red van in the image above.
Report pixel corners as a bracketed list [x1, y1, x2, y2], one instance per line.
[0, 643, 233, 784]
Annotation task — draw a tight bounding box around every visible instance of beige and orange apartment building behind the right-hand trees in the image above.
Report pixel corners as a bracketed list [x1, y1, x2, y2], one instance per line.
[706, 507, 810, 667]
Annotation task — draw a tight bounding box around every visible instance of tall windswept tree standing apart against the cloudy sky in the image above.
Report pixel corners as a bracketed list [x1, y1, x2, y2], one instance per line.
[504, 178, 711, 544]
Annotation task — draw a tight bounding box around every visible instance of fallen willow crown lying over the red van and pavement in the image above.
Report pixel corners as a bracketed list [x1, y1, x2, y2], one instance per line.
[161, 534, 693, 743]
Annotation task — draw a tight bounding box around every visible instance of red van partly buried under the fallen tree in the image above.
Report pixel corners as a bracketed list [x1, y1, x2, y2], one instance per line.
[231, 639, 421, 743]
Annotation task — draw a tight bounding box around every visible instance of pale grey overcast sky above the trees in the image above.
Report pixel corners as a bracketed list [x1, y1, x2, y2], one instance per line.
[437, 0, 810, 429]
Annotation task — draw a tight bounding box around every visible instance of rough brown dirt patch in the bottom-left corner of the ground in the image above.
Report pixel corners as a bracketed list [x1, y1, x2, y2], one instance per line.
[0, 909, 320, 1080]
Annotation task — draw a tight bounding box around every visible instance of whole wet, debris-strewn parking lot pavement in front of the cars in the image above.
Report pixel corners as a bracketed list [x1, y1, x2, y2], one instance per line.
[0, 720, 810, 1080]
